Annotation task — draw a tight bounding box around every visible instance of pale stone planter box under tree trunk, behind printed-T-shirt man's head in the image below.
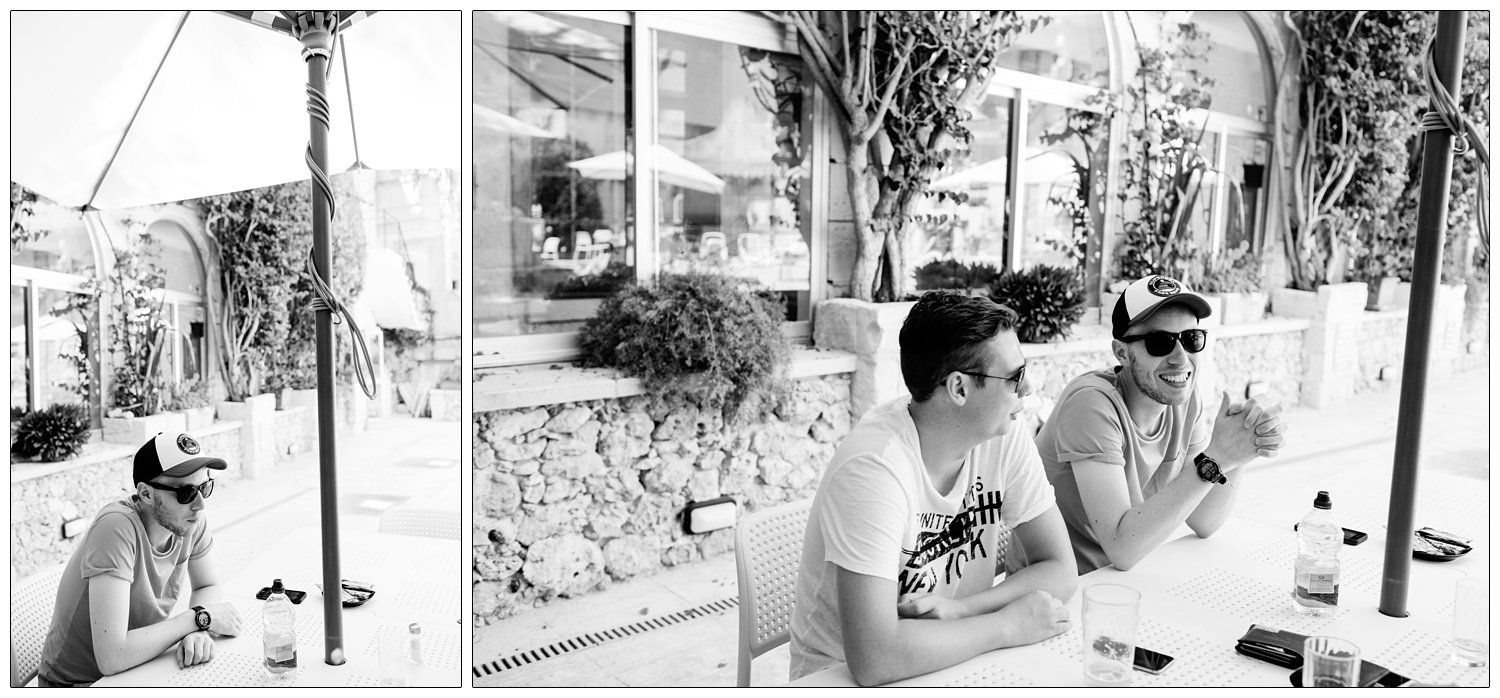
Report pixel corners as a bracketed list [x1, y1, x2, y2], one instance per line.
[813, 299, 917, 420]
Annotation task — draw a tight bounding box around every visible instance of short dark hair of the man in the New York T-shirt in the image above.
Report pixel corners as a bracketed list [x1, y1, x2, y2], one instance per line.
[902, 291, 1016, 402]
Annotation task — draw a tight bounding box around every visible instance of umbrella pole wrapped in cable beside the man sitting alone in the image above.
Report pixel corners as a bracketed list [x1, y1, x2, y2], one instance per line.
[296, 11, 344, 666]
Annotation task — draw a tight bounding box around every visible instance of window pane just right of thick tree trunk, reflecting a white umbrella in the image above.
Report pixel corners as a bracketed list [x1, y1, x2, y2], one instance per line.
[914, 95, 1014, 269]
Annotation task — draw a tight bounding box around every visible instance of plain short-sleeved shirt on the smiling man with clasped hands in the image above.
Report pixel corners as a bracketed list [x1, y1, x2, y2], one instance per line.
[1037, 369, 1212, 575]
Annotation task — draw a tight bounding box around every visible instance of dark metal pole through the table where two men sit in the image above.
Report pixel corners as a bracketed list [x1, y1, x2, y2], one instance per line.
[1380, 11, 1466, 618]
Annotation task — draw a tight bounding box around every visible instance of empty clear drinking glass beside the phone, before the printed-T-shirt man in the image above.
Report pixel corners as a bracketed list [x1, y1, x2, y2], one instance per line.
[1083, 584, 1140, 686]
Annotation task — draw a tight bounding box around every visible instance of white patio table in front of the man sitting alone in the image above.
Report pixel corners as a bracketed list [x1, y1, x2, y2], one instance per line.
[95, 527, 456, 687]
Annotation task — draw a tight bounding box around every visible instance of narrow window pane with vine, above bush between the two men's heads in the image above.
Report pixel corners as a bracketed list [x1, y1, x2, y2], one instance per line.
[1016, 102, 1109, 269]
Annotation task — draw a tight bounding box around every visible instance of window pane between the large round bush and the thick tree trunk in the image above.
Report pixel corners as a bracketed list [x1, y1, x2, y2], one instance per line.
[651, 32, 812, 320]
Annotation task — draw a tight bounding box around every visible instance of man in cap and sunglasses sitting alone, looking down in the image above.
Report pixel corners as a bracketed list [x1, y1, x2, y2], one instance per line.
[38, 434, 240, 687]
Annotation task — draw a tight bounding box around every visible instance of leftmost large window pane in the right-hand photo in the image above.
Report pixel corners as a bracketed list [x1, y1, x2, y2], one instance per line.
[473, 11, 636, 338]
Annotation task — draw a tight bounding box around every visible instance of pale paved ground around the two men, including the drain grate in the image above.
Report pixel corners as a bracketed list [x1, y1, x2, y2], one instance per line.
[474, 361, 1491, 686]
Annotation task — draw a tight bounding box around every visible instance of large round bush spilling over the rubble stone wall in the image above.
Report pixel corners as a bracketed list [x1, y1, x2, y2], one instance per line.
[579, 272, 791, 417]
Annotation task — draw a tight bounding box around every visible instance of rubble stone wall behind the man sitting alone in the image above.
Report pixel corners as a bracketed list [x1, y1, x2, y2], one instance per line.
[11, 428, 245, 578]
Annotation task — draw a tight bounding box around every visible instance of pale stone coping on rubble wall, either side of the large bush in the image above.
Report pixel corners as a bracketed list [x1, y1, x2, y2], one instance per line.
[474, 347, 855, 413]
